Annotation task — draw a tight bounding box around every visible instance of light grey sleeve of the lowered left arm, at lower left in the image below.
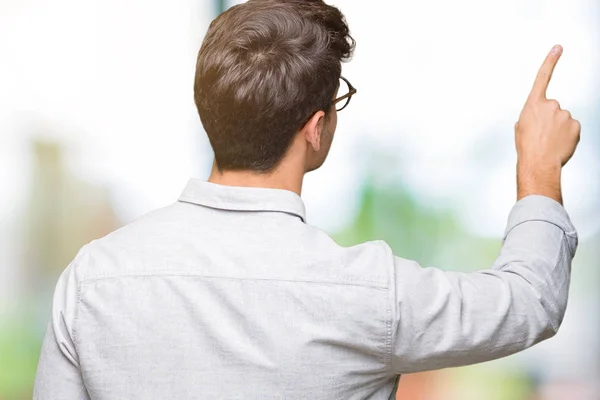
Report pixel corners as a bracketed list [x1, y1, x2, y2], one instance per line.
[33, 252, 89, 400]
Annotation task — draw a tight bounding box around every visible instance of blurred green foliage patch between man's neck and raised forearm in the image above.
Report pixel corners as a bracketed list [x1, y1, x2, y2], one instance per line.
[333, 180, 502, 271]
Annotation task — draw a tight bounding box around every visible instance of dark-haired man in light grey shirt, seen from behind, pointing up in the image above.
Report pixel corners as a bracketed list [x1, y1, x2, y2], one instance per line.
[35, 0, 580, 399]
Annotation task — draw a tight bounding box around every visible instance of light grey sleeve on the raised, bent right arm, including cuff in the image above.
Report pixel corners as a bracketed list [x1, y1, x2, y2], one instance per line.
[391, 195, 577, 374]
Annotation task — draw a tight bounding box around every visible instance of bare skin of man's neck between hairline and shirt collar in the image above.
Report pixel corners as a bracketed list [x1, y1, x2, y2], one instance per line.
[208, 164, 304, 196]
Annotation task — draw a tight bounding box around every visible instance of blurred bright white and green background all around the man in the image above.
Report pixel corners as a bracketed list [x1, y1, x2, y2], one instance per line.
[0, 0, 600, 400]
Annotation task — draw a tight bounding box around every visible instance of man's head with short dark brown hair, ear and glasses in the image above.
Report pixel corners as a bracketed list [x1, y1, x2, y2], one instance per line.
[194, 0, 354, 172]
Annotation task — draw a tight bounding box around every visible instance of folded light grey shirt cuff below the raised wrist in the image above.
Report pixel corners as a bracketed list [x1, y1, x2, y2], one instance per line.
[502, 195, 577, 250]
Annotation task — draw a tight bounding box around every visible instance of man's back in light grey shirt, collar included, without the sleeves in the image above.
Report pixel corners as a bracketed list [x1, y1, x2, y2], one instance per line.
[39, 182, 396, 399]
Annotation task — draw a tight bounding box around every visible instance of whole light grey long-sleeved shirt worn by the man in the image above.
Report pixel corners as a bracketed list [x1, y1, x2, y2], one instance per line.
[35, 180, 574, 399]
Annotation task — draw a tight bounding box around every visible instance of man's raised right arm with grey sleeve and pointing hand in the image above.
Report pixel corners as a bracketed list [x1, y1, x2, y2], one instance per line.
[391, 46, 580, 373]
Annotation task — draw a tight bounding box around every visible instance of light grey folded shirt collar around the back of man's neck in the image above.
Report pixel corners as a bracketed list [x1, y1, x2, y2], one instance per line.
[179, 179, 306, 222]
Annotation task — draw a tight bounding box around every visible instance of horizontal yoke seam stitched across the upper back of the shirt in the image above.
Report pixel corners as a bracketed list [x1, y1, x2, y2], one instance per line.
[82, 271, 388, 290]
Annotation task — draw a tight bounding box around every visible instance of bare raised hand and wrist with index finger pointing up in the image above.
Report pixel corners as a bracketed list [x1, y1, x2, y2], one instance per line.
[515, 46, 581, 204]
